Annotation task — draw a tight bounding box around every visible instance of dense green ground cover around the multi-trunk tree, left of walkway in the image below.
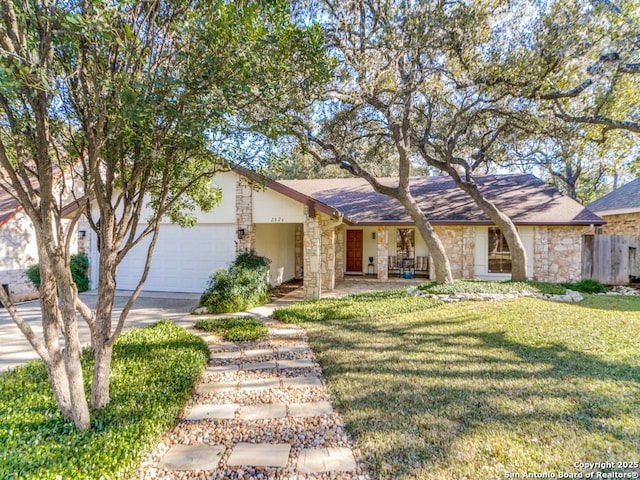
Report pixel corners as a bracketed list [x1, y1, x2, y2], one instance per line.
[0, 321, 209, 480]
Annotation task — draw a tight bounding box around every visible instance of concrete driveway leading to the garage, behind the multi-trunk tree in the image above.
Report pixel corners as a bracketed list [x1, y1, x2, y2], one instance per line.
[0, 291, 200, 372]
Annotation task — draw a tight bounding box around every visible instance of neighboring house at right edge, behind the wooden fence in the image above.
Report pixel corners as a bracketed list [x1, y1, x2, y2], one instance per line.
[587, 178, 640, 235]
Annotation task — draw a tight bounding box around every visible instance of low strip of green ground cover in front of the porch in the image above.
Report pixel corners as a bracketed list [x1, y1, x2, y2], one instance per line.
[273, 289, 442, 323]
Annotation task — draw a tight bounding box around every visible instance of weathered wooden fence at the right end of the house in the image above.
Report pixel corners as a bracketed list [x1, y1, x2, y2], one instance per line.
[582, 235, 640, 285]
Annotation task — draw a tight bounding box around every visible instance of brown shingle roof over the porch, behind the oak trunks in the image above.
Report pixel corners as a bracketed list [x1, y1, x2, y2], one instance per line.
[279, 174, 605, 225]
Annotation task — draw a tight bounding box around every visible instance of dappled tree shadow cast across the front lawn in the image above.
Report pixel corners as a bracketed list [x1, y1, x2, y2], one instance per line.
[310, 314, 640, 478]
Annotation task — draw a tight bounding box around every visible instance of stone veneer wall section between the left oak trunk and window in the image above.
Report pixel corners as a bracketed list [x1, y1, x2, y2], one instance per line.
[430, 225, 476, 278]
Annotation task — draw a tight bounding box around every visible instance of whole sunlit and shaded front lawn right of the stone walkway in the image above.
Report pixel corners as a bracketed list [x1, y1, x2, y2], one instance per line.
[276, 295, 640, 480]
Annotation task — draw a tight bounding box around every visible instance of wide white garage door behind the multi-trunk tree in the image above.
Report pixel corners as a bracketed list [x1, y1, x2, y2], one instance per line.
[116, 225, 235, 293]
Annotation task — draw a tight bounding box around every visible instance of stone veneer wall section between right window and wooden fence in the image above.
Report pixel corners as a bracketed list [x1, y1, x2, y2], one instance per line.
[533, 225, 583, 283]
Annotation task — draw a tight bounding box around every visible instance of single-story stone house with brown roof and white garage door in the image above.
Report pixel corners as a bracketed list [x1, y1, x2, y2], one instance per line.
[90, 168, 604, 298]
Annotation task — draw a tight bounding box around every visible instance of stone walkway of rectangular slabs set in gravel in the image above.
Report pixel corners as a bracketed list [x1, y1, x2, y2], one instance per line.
[138, 300, 370, 480]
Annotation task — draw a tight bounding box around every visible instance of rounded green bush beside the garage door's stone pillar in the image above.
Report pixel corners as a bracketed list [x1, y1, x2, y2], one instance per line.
[200, 253, 271, 313]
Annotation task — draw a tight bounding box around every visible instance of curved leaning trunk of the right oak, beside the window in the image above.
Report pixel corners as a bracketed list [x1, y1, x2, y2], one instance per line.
[462, 183, 527, 282]
